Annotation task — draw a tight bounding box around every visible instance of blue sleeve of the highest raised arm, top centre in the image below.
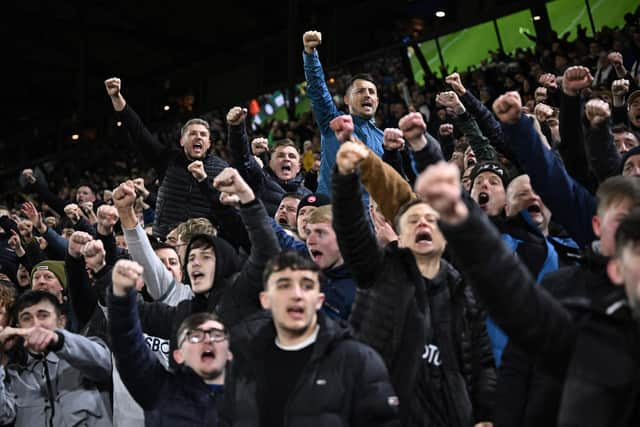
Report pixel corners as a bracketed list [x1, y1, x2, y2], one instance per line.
[302, 50, 340, 134]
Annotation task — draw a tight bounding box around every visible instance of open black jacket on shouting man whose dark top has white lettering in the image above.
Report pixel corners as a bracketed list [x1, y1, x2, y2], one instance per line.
[332, 174, 496, 425]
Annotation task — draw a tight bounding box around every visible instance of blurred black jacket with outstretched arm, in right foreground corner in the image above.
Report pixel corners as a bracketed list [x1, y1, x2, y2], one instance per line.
[441, 201, 640, 427]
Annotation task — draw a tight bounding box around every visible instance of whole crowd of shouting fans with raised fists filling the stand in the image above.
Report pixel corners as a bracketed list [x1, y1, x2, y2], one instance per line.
[0, 9, 640, 427]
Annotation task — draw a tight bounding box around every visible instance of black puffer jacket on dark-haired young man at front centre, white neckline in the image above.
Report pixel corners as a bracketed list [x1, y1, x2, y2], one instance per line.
[220, 311, 399, 427]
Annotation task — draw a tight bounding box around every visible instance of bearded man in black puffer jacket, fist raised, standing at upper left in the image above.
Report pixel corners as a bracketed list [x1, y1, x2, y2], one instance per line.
[104, 77, 232, 238]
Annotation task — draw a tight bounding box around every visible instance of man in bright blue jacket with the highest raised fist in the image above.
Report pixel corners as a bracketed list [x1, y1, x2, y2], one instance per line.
[302, 31, 383, 201]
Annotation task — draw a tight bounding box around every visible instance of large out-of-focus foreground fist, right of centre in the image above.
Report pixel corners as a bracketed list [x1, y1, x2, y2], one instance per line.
[415, 162, 469, 224]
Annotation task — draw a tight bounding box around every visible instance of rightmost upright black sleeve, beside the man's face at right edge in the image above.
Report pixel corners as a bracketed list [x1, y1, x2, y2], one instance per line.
[586, 121, 622, 182]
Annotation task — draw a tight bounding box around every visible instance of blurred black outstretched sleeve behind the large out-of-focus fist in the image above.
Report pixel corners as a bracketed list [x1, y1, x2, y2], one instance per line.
[440, 202, 577, 380]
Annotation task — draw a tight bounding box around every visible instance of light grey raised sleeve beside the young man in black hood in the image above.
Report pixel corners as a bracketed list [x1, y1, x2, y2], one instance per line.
[123, 224, 194, 306]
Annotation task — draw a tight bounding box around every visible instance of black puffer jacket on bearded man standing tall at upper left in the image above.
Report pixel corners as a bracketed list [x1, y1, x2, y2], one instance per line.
[120, 104, 229, 237]
